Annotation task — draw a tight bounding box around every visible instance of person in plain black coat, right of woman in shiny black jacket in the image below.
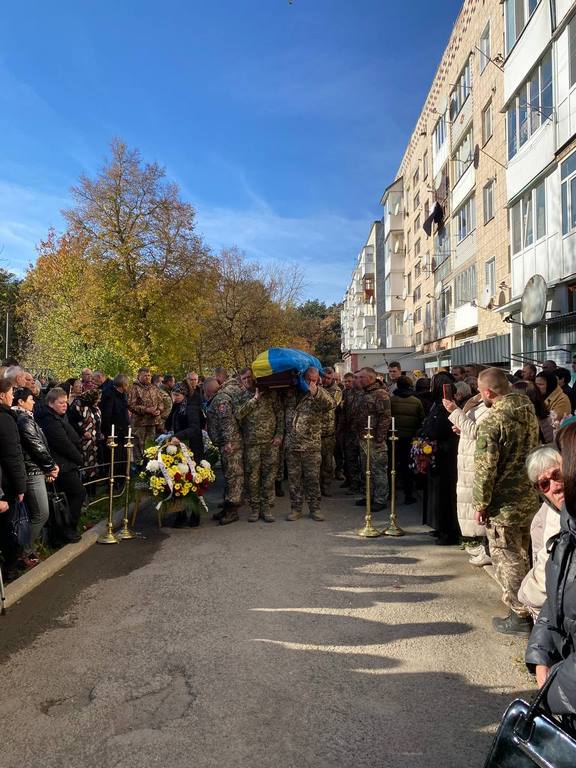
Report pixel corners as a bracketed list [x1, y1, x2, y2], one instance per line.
[36, 387, 86, 529]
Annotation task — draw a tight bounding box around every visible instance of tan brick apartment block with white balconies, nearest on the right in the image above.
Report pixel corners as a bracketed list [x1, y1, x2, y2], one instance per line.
[343, 0, 576, 371]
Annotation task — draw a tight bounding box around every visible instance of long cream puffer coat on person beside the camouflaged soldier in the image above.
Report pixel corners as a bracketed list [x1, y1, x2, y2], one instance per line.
[448, 402, 490, 537]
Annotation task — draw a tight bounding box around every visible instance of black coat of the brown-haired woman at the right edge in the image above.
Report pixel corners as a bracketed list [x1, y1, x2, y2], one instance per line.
[526, 509, 576, 715]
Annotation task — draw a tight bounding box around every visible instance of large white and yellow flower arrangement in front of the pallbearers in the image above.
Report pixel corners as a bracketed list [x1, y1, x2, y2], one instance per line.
[140, 442, 216, 507]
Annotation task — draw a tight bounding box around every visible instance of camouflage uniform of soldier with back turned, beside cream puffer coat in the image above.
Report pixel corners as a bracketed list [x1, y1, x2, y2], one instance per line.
[472, 392, 539, 617]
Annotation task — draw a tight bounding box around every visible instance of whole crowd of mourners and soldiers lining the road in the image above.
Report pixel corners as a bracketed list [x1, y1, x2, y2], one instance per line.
[0, 359, 576, 713]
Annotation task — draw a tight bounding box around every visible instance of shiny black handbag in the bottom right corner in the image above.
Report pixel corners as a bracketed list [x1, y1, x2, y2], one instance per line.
[484, 668, 576, 768]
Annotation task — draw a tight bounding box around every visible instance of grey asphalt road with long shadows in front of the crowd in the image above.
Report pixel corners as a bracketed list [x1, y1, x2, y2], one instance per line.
[0, 486, 532, 768]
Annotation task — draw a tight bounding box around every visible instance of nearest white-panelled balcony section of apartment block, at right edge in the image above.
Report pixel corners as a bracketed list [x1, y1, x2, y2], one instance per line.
[501, 0, 576, 364]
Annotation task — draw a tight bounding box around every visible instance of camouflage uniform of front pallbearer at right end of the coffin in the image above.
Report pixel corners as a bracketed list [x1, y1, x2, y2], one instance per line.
[286, 386, 333, 519]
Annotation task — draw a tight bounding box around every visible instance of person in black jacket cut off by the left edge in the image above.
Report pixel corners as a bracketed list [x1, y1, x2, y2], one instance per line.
[0, 379, 26, 579]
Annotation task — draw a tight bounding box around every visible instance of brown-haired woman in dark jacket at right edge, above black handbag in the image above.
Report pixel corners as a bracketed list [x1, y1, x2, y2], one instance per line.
[526, 423, 576, 715]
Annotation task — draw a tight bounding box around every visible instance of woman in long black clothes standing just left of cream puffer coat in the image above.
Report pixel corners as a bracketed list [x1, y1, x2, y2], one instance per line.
[422, 373, 460, 544]
